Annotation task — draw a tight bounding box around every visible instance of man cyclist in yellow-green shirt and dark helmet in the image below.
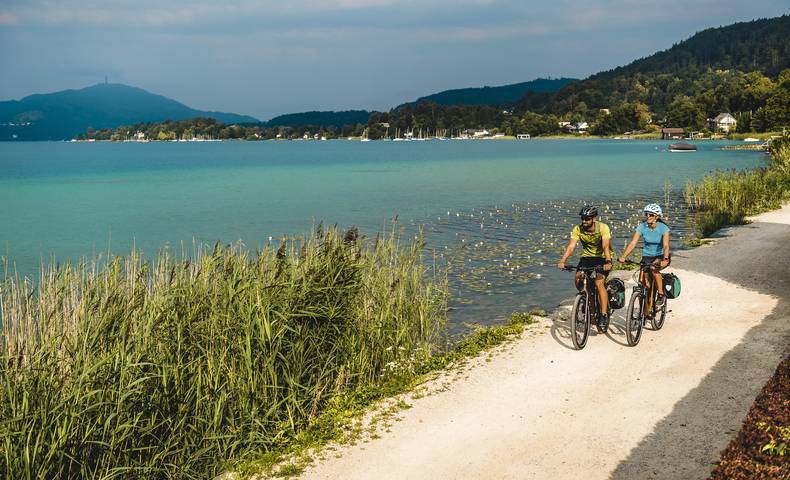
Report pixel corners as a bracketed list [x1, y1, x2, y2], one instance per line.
[557, 205, 612, 329]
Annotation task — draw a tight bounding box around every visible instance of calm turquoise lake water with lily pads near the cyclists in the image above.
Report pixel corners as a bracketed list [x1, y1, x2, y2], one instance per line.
[0, 140, 766, 325]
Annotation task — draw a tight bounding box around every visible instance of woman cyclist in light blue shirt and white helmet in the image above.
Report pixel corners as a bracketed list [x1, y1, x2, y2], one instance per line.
[617, 203, 672, 307]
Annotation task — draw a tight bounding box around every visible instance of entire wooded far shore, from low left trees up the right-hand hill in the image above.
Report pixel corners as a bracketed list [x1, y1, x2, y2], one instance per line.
[83, 15, 790, 140]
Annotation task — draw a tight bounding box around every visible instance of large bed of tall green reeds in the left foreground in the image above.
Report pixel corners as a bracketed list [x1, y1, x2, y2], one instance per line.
[0, 229, 447, 479]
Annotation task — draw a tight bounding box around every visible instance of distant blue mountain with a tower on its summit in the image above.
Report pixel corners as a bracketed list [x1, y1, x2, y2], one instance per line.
[0, 83, 258, 140]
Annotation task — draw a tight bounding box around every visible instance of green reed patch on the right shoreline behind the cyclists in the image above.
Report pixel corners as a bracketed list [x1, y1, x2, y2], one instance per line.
[684, 137, 790, 237]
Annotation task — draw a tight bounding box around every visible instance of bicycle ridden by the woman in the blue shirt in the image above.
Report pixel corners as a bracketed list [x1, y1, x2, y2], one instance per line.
[623, 260, 667, 347]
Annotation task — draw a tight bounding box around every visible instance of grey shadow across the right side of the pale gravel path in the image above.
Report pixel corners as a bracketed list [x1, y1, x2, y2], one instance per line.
[610, 223, 790, 480]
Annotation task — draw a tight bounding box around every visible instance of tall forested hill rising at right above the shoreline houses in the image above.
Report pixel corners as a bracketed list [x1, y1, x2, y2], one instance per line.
[540, 15, 790, 117]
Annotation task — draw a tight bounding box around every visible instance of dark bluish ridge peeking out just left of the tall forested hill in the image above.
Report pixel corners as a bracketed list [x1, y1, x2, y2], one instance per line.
[417, 78, 576, 105]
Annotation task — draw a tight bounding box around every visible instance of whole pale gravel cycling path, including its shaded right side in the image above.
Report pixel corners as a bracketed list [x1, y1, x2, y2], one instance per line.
[301, 206, 790, 480]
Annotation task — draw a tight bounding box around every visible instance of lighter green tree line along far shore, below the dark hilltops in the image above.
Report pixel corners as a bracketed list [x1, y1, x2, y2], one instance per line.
[79, 69, 790, 140]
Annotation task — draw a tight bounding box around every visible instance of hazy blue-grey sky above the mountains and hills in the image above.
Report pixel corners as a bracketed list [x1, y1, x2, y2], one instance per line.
[0, 0, 790, 120]
